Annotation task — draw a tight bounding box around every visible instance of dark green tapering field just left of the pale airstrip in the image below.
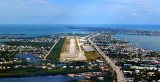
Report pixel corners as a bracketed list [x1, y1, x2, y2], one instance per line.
[47, 38, 66, 62]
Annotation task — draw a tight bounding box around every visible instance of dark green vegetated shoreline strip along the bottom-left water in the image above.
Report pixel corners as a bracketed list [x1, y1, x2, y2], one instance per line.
[0, 69, 100, 78]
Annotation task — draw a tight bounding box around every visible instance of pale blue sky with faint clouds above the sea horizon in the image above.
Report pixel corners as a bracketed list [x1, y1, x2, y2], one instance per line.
[0, 0, 160, 24]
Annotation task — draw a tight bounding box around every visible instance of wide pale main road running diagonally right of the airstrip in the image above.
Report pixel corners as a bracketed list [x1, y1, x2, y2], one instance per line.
[88, 34, 126, 82]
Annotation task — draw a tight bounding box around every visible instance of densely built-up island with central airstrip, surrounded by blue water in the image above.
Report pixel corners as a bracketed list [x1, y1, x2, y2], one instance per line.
[0, 27, 160, 82]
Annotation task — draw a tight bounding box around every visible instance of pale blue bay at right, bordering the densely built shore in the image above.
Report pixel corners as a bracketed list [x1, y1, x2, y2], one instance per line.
[115, 34, 160, 52]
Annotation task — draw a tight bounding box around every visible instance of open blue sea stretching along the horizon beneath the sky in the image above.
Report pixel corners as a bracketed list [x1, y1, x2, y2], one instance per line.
[0, 24, 160, 36]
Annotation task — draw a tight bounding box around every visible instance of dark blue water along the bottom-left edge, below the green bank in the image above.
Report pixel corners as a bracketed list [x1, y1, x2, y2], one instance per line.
[0, 75, 82, 82]
